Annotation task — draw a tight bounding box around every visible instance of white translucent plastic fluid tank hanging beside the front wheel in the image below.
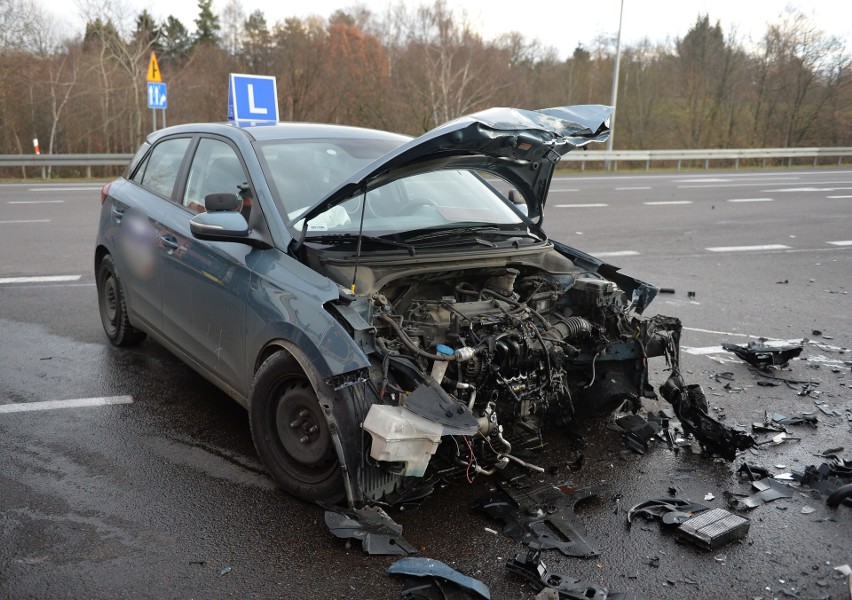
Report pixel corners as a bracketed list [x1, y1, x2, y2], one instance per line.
[364, 404, 442, 477]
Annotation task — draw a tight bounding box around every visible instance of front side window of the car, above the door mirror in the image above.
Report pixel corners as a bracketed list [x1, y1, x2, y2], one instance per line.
[183, 138, 252, 220]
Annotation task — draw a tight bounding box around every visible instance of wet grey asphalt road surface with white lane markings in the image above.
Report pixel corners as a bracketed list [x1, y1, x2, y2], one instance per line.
[0, 169, 852, 599]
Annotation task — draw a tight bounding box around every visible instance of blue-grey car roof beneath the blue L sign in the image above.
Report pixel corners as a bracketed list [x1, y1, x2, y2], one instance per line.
[148, 122, 411, 144]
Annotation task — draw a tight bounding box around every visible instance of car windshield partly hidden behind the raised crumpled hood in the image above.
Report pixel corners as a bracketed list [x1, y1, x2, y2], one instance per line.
[262, 139, 522, 235]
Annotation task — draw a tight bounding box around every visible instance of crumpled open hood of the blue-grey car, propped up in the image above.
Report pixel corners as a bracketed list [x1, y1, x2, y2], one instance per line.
[290, 104, 613, 227]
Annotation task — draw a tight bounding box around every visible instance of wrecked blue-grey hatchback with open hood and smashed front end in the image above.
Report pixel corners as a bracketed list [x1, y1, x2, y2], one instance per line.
[94, 106, 709, 506]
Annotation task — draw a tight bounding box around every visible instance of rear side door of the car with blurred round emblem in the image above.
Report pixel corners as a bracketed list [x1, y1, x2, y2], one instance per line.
[112, 136, 192, 333]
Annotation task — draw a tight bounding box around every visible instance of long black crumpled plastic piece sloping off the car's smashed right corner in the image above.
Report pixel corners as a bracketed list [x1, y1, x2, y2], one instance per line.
[660, 374, 755, 461]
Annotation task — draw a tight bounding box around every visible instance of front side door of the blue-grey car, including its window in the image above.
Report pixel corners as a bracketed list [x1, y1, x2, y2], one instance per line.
[161, 137, 253, 395]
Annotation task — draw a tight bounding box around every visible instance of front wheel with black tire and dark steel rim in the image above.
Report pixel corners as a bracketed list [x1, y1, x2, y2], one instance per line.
[249, 350, 344, 502]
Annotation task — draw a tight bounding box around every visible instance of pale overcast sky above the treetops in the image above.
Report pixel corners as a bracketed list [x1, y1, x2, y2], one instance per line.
[56, 0, 852, 58]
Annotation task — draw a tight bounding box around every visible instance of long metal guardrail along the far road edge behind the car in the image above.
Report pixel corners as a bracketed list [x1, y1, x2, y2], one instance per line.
[0, 147, 852, 177]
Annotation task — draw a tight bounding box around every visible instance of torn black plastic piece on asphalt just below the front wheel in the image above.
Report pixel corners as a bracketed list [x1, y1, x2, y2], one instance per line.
[325, 506, 417, 556]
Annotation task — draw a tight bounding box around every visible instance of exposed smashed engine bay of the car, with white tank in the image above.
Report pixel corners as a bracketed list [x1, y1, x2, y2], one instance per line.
[312, 244, 700, 500]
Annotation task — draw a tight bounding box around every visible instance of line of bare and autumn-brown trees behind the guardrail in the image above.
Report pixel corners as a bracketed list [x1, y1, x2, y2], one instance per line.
[0, 0, 852, 165]
